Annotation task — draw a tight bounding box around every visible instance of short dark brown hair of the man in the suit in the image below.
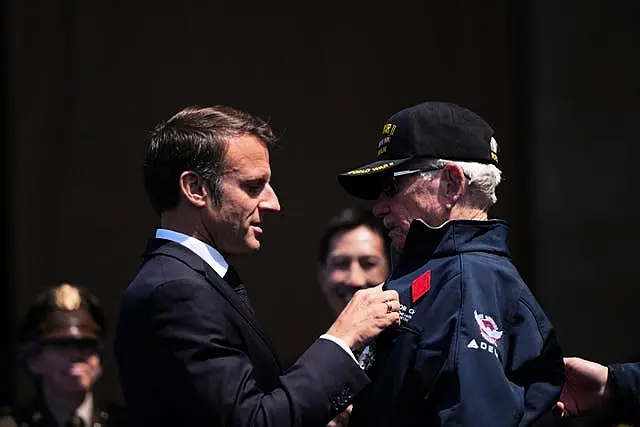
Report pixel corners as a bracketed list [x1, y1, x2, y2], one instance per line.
[143, 106, 275, 214]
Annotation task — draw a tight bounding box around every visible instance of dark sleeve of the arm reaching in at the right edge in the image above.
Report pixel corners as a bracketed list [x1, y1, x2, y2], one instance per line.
[609, 363, 640, 423]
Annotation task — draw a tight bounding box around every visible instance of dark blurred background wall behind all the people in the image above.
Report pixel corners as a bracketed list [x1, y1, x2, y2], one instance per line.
[0, 0, 640, 403]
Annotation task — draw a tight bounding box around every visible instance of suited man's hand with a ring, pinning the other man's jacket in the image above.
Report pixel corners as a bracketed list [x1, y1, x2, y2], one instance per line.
[327, 285, 400, 350]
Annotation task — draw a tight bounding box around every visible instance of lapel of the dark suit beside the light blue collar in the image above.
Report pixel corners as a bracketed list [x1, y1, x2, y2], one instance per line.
[144, 239, 282, 369]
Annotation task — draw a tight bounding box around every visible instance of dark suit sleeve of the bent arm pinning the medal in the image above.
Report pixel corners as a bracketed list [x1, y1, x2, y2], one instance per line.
[150, 281, 369, 427]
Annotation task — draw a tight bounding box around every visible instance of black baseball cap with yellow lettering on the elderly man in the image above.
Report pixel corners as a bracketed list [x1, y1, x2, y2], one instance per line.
[338, 102, 499, 200]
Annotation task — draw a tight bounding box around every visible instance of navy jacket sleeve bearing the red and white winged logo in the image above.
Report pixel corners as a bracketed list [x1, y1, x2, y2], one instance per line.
[434, 282, 563, 427]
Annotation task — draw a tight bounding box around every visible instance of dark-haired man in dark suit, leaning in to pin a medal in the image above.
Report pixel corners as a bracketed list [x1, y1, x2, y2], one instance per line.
[115, 107, 400, 427]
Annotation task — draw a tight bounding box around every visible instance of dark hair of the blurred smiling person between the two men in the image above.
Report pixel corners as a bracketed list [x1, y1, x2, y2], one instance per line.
[318, 208, 391, 265]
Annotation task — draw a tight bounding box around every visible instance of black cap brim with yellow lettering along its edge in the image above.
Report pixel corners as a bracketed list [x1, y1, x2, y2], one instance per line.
[338, 157, 411, 200]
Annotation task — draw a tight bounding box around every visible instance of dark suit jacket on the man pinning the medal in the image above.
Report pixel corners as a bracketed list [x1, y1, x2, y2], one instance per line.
[115, 239, 369, 427]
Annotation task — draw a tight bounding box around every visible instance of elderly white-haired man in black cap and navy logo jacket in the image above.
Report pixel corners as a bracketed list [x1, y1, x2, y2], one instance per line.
[338, 102, 563, 427]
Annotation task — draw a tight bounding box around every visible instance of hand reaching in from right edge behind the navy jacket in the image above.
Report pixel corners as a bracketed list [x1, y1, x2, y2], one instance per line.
[555, 357, 610, 417]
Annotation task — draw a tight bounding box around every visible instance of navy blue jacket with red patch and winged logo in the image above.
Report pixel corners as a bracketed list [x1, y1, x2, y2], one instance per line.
[350, 221, 564, 427]
